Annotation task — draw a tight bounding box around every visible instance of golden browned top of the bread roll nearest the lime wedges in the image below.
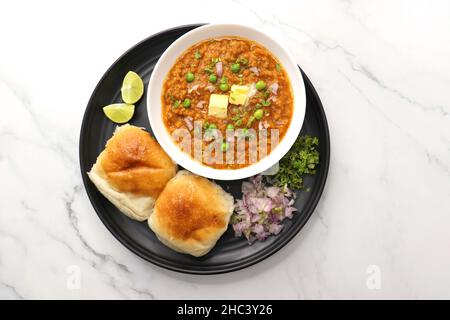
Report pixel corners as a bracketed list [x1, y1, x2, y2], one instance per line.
[100, 125, 176, 197]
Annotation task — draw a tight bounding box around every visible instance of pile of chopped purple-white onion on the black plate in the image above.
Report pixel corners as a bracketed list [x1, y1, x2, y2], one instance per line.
[231, 175, 297, 243]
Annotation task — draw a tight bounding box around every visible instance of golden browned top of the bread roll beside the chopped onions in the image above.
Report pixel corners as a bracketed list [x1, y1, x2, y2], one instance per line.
[153, 172, 233, 242]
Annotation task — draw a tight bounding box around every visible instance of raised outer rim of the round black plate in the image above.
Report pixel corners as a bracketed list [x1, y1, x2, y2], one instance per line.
[78, 23, 331, 275]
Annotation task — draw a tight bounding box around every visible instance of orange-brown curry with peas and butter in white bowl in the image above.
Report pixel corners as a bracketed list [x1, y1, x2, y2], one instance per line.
[161, 37, 293, 169]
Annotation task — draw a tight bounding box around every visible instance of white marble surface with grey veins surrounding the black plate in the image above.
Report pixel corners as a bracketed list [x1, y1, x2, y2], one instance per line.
[0, 0, 450, 299]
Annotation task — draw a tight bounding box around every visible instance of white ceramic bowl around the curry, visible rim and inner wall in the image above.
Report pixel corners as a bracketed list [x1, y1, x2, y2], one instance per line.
[147, 24, 306, 180]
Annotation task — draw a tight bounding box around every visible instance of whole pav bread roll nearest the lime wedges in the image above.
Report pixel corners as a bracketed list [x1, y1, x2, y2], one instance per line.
[88, 124, 177, 221]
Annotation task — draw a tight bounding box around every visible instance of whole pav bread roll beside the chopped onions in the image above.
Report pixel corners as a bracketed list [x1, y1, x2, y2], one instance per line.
[148, 170, 234, 257]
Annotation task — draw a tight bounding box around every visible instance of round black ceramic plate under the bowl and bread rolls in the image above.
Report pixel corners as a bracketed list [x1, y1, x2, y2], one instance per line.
[80, 25, 330, 274]
